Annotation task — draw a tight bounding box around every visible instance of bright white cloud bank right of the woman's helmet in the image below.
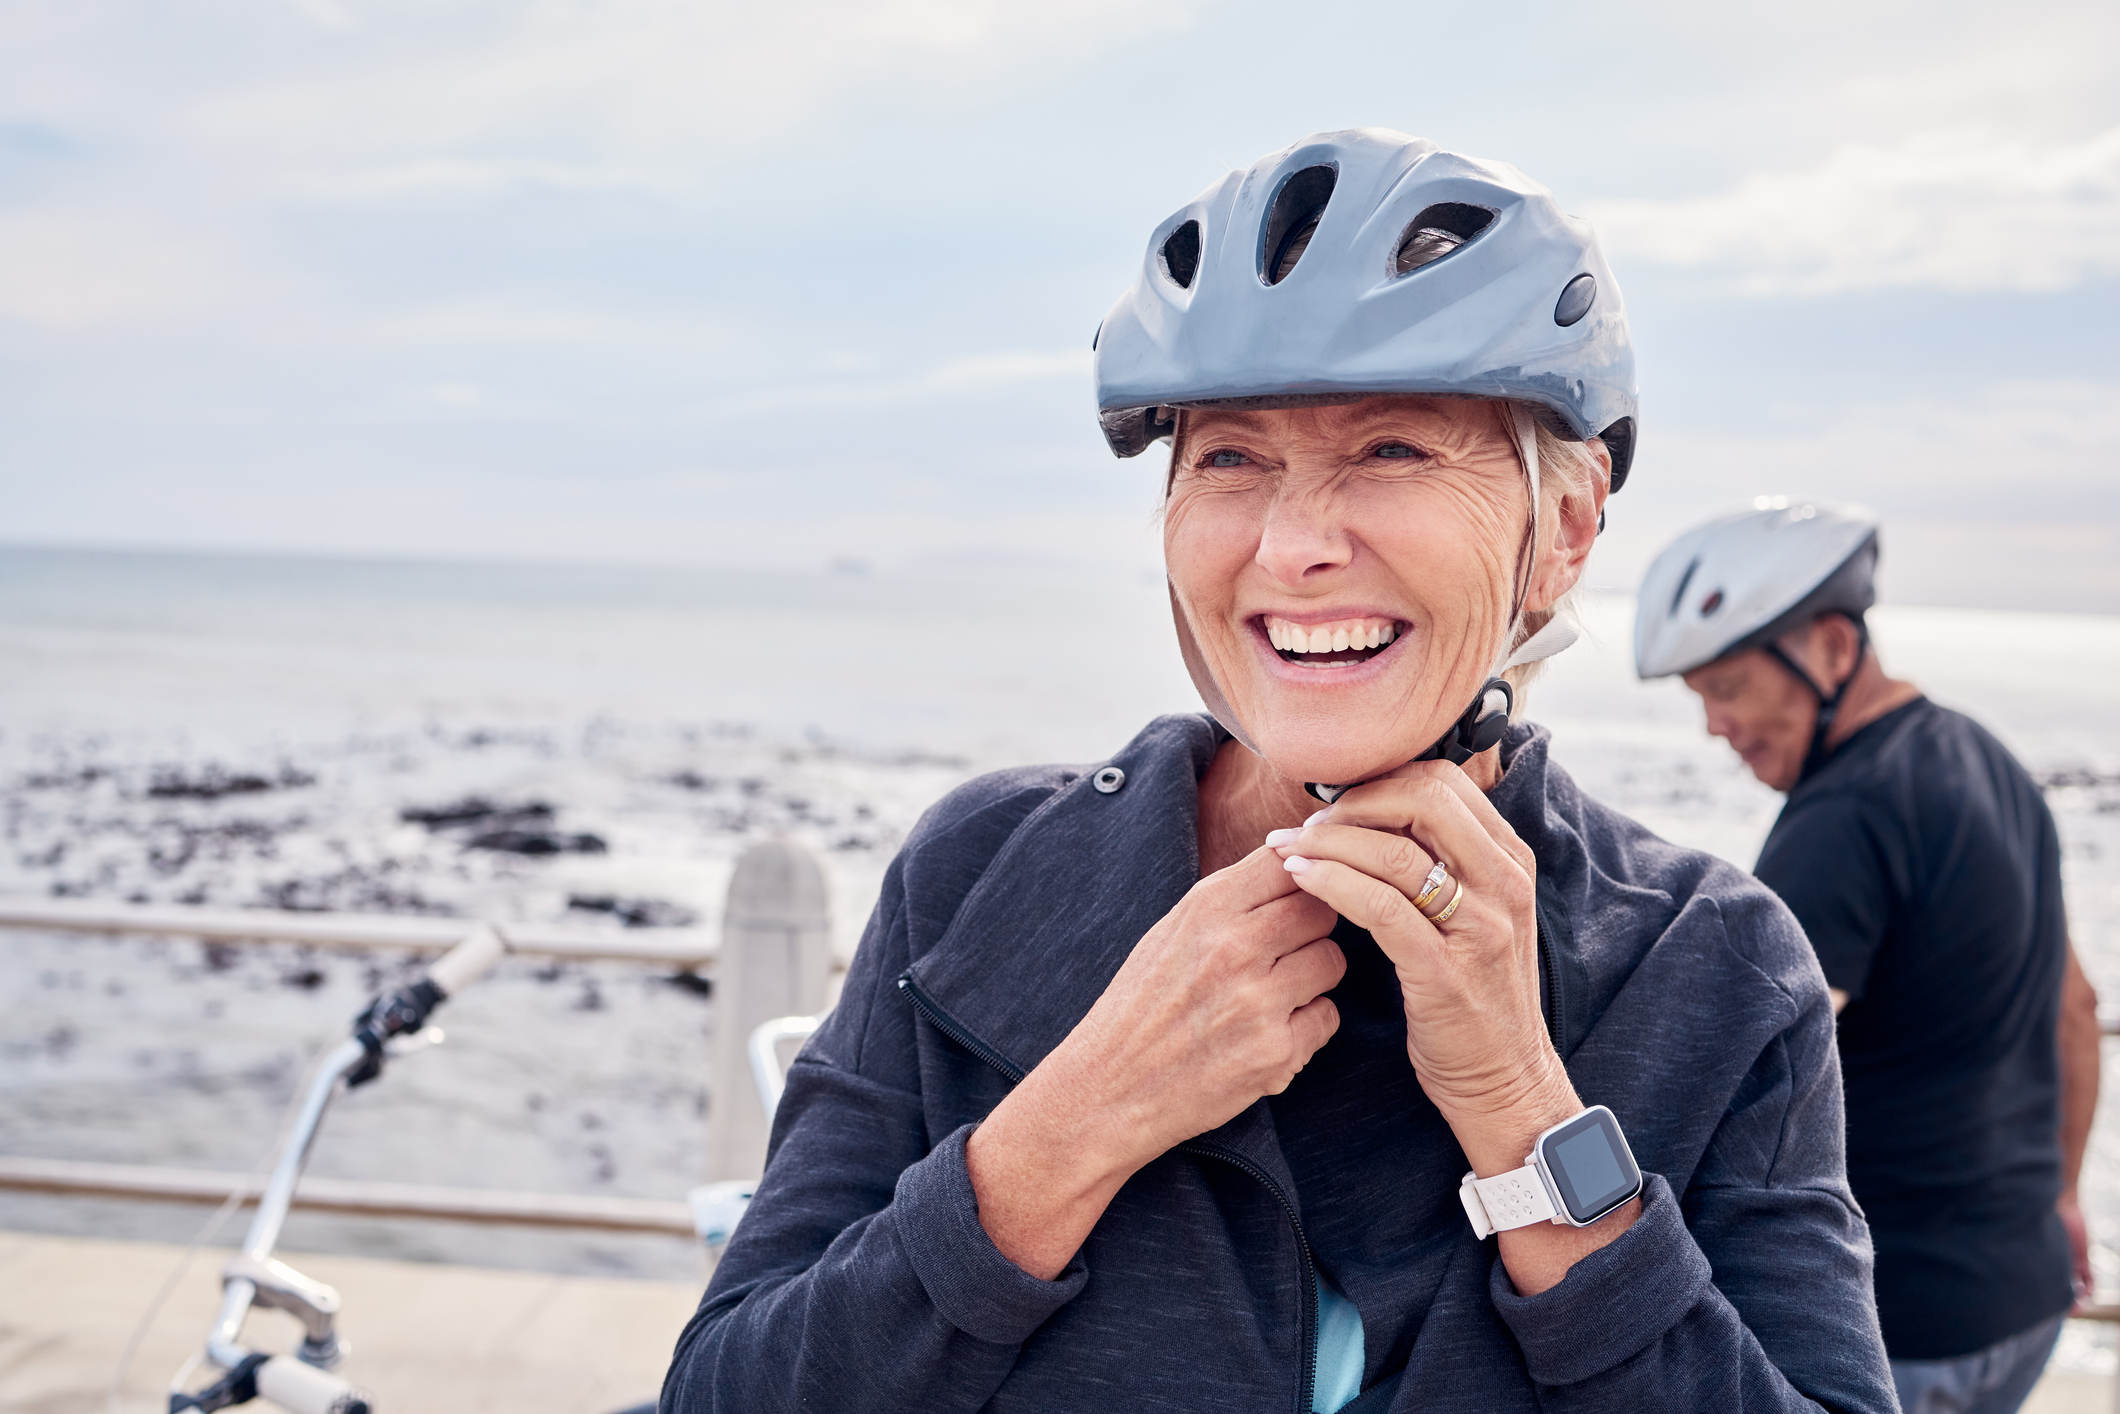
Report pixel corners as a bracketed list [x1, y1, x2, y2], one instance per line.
[1588, 127, 2120, 295]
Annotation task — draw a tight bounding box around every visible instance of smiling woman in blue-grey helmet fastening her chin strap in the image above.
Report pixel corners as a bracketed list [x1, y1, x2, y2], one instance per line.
[661, 129, 1895, 1414]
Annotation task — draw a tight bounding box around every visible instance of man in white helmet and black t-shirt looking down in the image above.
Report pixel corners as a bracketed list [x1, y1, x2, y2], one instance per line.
[1635, 500, 2099, 1414]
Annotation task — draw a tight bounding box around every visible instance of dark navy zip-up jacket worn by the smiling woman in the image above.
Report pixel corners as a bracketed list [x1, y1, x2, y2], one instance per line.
[661, 717, 1897, 1414]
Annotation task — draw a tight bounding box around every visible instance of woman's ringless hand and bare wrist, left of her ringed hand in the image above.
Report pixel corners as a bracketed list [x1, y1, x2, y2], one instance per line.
[967, 848, 1346, 1280]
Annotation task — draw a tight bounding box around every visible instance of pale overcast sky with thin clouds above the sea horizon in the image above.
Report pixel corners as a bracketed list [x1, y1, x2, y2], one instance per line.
[0, 0, 2120, 611]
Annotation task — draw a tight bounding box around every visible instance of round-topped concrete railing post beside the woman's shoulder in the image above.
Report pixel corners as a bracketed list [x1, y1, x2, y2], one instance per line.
[706, 839, 831, 1179]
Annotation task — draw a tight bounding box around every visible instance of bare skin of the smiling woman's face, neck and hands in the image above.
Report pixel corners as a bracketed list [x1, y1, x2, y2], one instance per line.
[967, 399, 1639, 1293]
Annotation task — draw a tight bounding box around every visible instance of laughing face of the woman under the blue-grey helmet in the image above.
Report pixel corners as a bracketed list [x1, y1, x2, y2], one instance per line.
[1164, 396, 1594, 782]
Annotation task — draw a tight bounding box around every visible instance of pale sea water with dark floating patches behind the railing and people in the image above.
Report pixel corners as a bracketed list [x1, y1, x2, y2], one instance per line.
[0, 549, 2120, 1356]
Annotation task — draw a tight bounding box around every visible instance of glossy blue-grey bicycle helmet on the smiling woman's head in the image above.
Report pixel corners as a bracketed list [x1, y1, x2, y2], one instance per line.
[1092, 127, 1635, 490]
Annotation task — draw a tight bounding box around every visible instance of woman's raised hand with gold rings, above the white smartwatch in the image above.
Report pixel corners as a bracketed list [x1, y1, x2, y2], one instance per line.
[1268, 761, 1639, 1293]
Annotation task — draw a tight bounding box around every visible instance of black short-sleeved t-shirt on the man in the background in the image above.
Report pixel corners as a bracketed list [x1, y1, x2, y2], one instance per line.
[1757, 697, 2073, 1359]
